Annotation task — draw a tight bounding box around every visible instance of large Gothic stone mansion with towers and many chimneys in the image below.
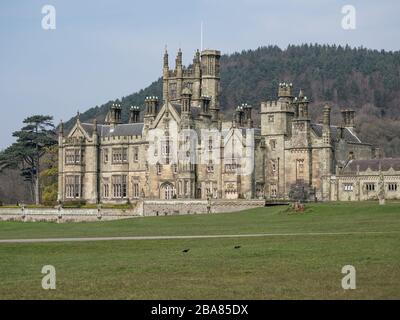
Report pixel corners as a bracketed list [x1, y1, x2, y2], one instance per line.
[58, 50, 400, 203]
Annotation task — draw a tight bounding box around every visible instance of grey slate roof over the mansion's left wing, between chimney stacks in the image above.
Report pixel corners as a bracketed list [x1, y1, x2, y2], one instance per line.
[82, 122, 144, 137]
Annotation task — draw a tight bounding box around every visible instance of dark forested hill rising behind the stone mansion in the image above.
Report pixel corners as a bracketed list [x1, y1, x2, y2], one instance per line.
[66, 44, 400, 157]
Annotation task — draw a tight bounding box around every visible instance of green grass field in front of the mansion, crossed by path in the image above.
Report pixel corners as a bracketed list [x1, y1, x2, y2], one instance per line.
[0, 202, 400, 299]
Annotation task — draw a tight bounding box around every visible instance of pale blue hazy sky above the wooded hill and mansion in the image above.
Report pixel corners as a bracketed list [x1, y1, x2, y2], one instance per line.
[0, 0, 400, 149]
